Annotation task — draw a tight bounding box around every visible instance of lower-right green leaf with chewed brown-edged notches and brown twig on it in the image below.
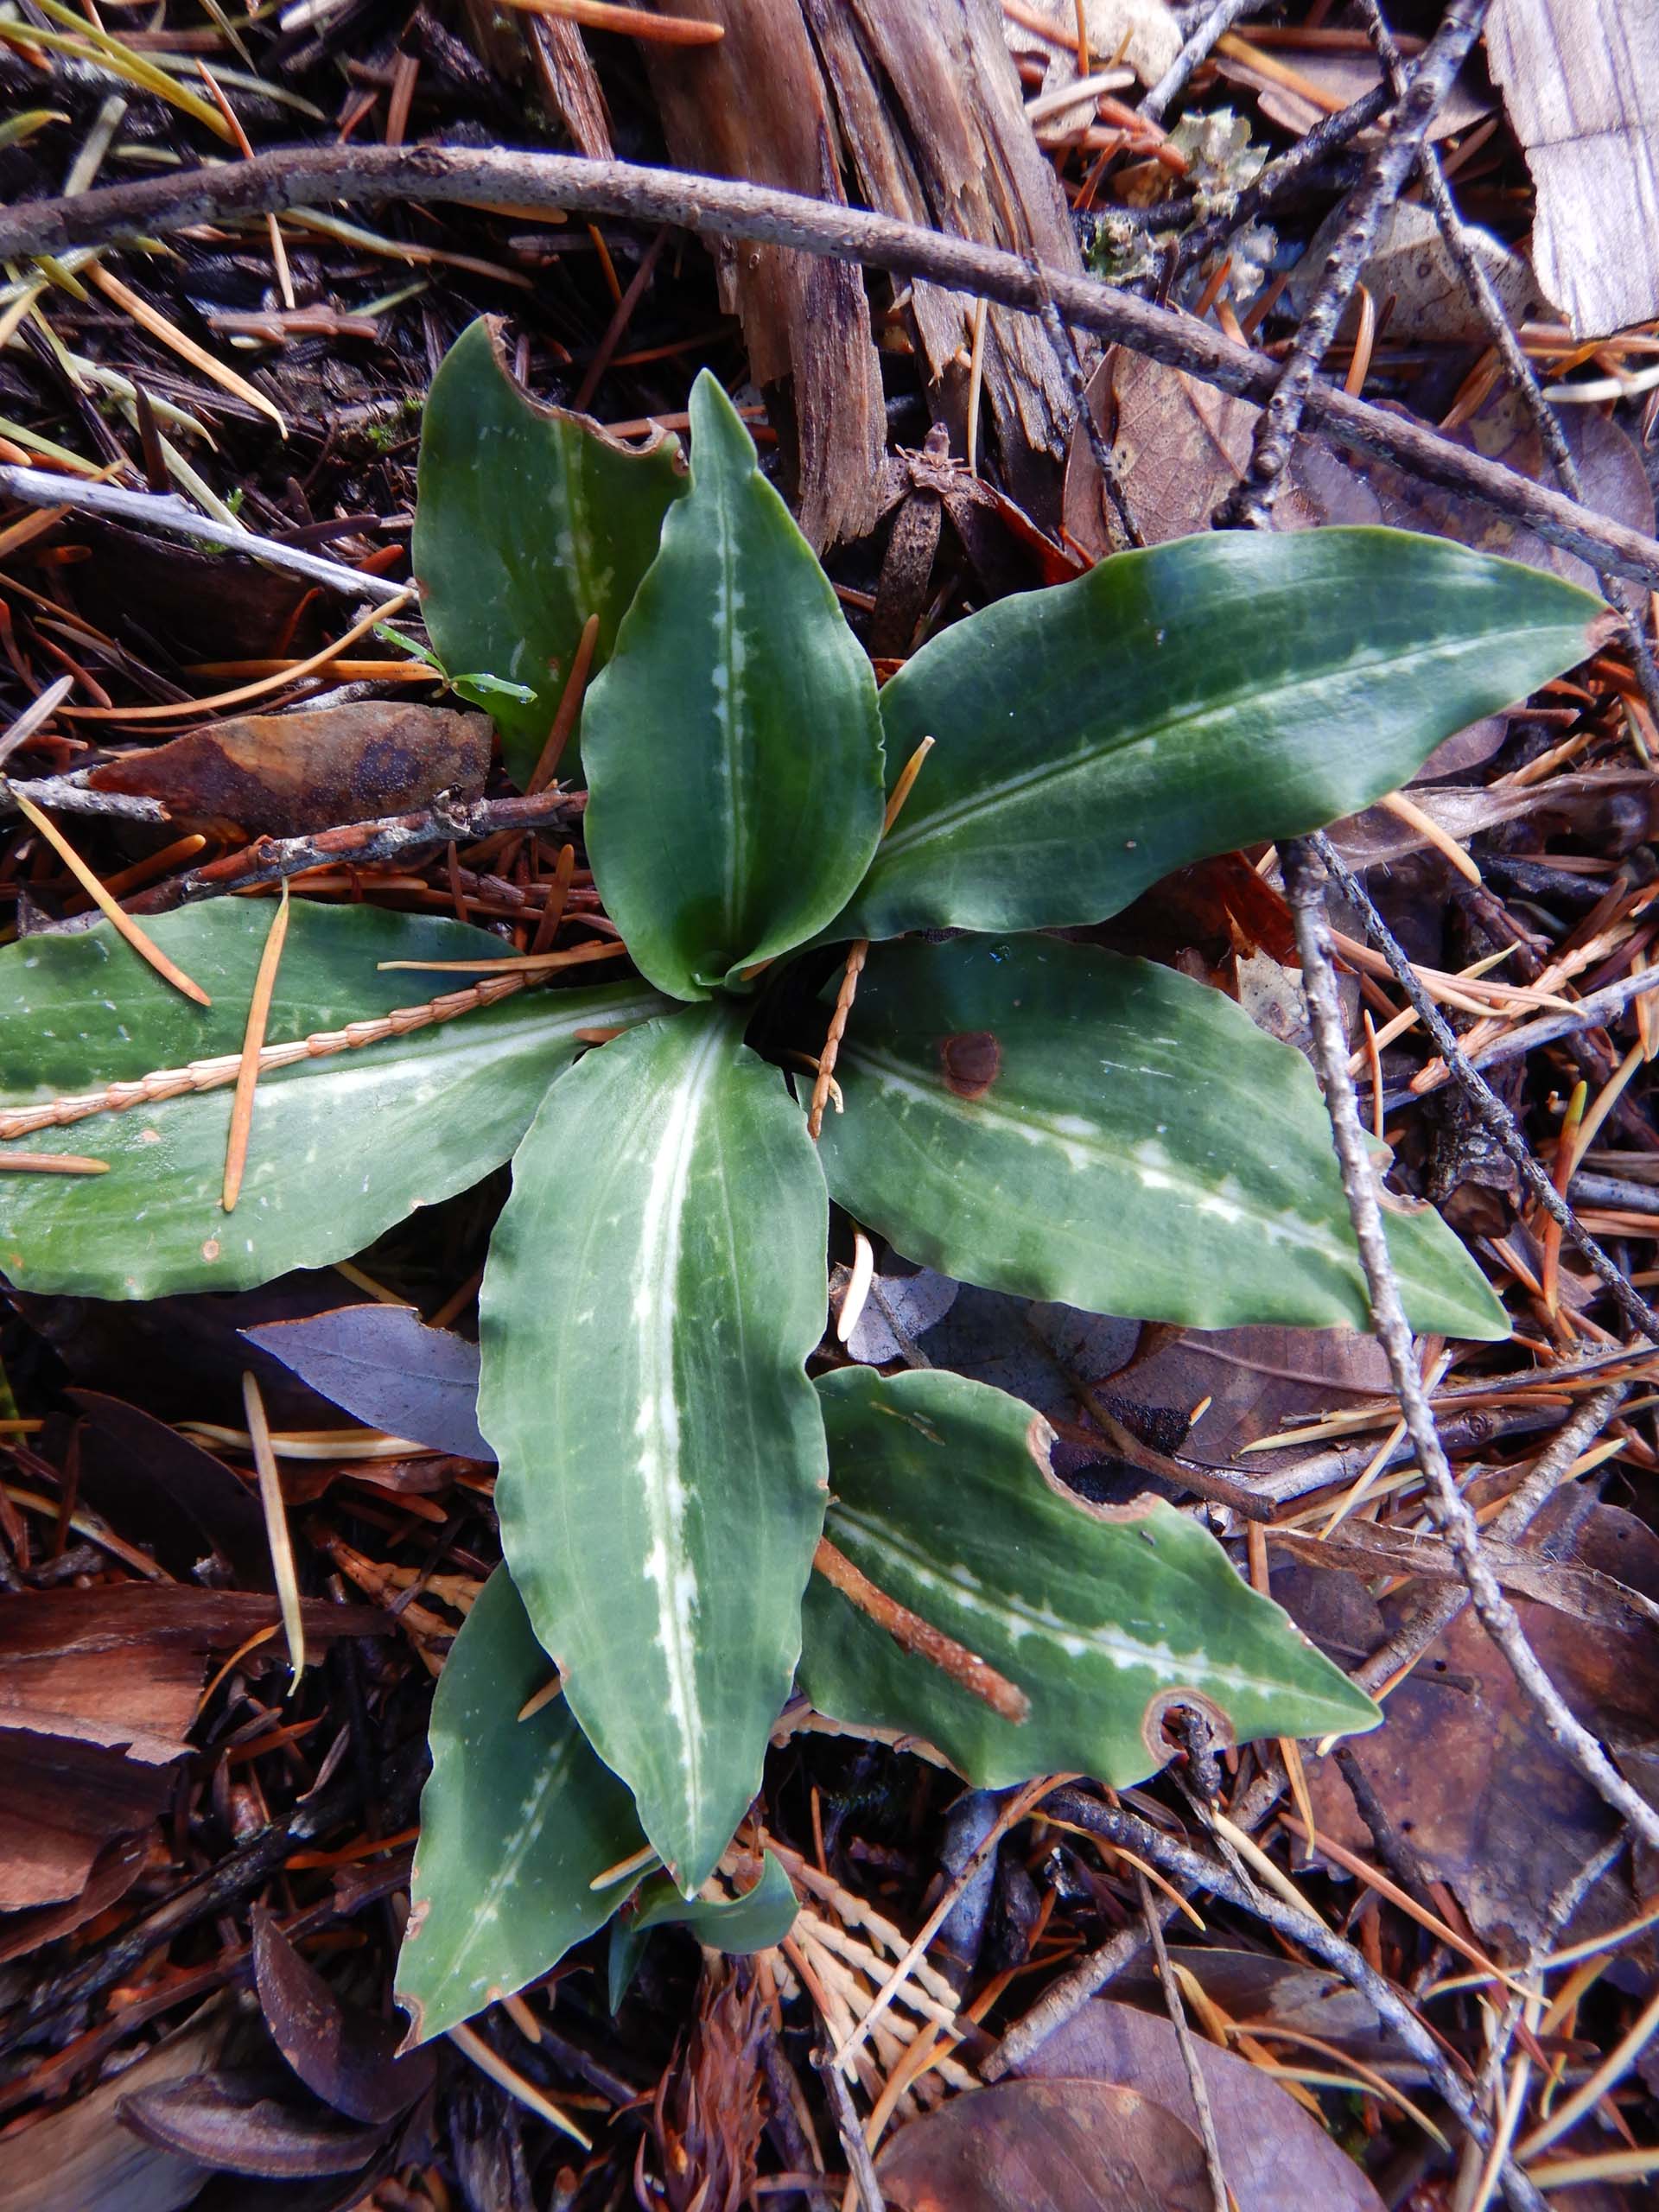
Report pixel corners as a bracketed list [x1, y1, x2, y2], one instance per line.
[801, 1367, 1380, 1787]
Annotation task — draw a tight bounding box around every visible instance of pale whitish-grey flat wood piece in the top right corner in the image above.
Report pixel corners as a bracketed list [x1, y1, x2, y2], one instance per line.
[1486, 0, 1659, 339]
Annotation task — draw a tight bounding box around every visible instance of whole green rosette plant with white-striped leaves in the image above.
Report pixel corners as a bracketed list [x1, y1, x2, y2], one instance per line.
[0, 325, 1601, 2035]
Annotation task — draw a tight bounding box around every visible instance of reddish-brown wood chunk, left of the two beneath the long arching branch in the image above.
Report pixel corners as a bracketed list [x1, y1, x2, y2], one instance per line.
[644, 0, 887, 550]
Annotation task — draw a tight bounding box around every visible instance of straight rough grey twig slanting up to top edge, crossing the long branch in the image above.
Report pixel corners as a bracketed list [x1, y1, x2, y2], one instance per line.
[1217, 0, 1491, 526]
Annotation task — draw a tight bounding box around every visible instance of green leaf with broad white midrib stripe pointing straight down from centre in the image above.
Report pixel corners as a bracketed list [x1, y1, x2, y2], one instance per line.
[478, 1004, 827, 1896]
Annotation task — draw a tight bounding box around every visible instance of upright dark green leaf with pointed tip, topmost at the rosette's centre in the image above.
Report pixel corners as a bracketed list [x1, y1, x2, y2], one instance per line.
[582, 372, 882, 1000]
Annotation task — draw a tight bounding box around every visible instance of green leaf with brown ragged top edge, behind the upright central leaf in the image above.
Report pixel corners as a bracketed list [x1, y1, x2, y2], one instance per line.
[414, 316, 686, 785]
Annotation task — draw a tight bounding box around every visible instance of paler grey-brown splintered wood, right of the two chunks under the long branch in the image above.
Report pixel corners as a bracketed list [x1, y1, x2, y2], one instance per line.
[803, 0, 1096, 529]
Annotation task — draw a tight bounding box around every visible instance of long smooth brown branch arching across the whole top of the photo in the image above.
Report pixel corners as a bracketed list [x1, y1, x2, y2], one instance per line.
[0, 146, 1659, 584]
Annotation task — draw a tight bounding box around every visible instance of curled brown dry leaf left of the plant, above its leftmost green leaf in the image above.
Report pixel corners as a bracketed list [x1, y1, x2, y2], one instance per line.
[86, 699, 491, 836]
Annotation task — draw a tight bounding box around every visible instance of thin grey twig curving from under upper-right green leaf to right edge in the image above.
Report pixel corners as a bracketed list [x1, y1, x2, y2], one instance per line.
[1283, 838, 1659, 1849]
